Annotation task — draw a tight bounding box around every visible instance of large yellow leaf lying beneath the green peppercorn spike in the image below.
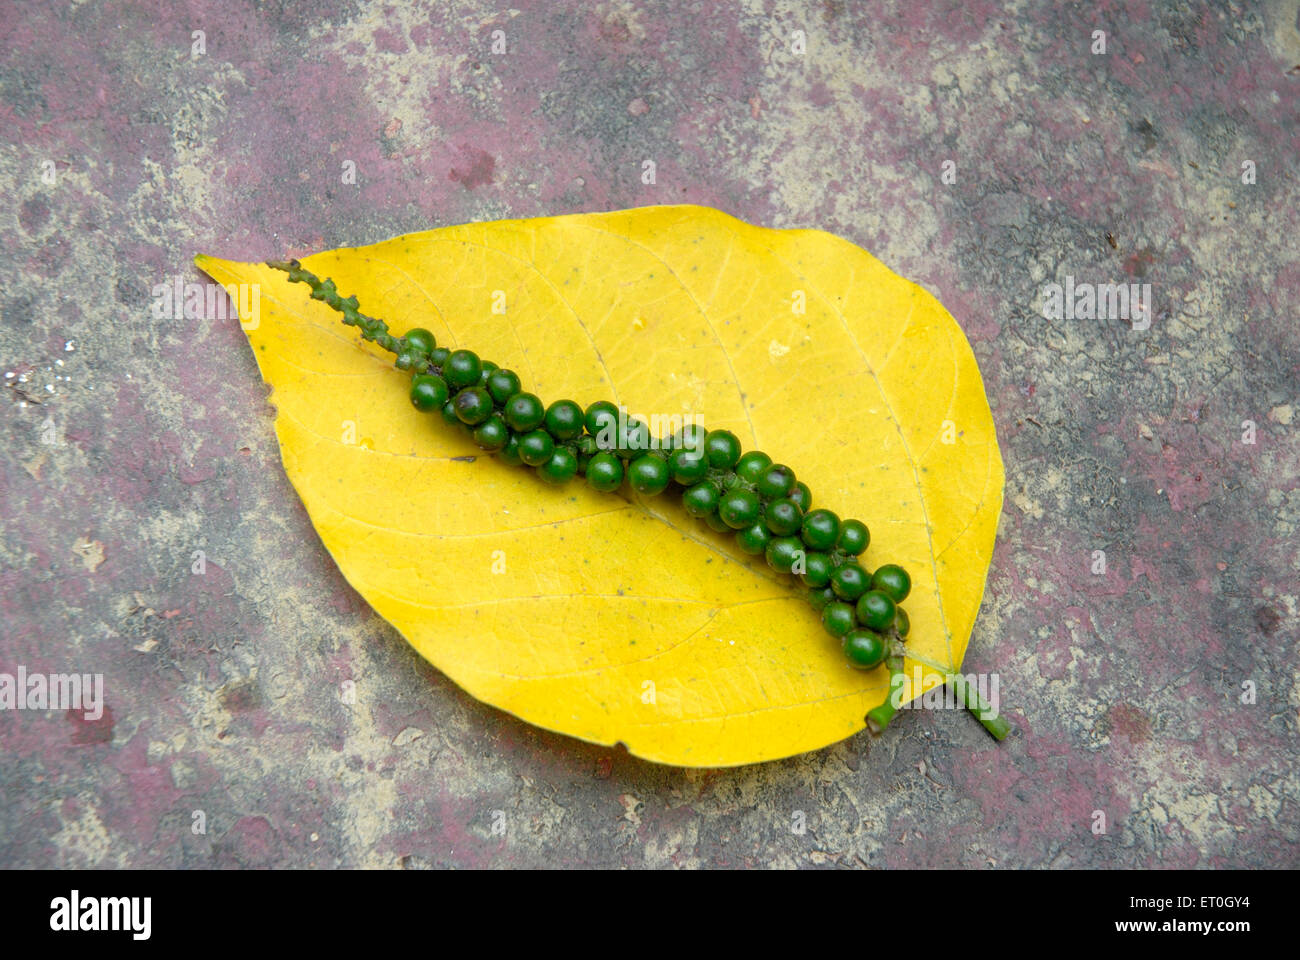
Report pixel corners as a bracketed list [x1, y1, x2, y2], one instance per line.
[198, 207, 1004, 766]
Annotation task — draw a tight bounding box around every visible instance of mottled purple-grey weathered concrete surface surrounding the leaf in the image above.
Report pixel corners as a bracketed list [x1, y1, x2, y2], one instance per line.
[0, 0, 1300, 868]
